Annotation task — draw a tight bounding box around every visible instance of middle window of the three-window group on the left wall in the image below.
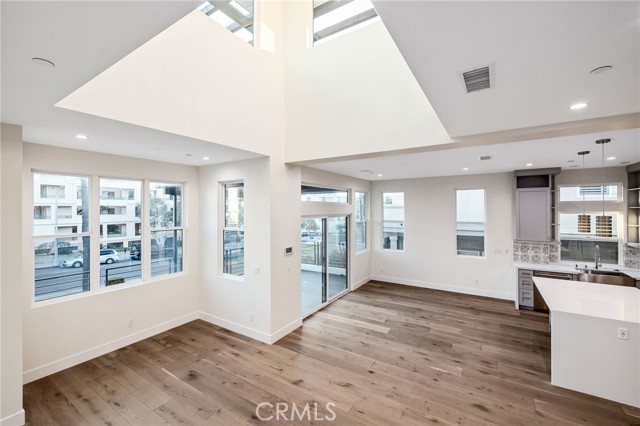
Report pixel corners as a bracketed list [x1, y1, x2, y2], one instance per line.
[100, 178, 142, 287]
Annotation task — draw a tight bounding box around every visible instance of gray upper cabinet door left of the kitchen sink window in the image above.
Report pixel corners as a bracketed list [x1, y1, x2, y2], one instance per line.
[516, 188, 552, 241]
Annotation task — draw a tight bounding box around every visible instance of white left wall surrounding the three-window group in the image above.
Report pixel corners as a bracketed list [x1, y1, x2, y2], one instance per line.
[21, 143, 200, 382]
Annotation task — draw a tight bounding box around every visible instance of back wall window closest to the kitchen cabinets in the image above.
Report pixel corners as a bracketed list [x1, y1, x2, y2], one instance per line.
[456, 189, 485, 257]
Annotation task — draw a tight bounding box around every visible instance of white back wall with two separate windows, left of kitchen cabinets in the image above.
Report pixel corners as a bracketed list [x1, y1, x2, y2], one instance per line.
[371, 173, 515, 300]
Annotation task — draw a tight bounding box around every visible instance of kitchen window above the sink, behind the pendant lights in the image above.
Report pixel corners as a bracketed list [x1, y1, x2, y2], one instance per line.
[556, 183, 623, 264]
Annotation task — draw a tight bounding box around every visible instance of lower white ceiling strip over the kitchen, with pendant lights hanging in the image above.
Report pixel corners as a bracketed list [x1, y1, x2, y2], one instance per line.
[311, 129, 640, 181]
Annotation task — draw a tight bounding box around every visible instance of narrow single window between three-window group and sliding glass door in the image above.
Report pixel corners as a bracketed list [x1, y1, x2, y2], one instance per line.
[222, 182, 244, 276]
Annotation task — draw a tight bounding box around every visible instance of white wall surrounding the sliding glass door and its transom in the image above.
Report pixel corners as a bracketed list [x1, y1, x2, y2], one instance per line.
[298, 167, 372, 289]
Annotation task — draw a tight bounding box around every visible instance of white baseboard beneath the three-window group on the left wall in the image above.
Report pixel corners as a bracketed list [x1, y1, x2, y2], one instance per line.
[23, 312, 200, 384]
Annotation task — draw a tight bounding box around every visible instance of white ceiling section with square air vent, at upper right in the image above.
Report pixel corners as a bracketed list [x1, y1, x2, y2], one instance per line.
[373, 0, 640, 137]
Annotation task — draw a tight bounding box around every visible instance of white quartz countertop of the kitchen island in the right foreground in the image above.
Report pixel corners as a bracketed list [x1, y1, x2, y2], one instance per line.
[533, 277, 640, 324]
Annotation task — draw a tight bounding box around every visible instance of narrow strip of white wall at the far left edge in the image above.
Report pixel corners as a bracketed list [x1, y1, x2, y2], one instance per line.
[0, 124, 25, 426]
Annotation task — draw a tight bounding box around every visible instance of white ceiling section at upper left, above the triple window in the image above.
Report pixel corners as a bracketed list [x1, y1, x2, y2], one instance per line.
[0, 0, 259, 165]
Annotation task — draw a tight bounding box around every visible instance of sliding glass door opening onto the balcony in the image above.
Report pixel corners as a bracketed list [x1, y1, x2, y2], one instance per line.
[300, 216, 349, 316]
